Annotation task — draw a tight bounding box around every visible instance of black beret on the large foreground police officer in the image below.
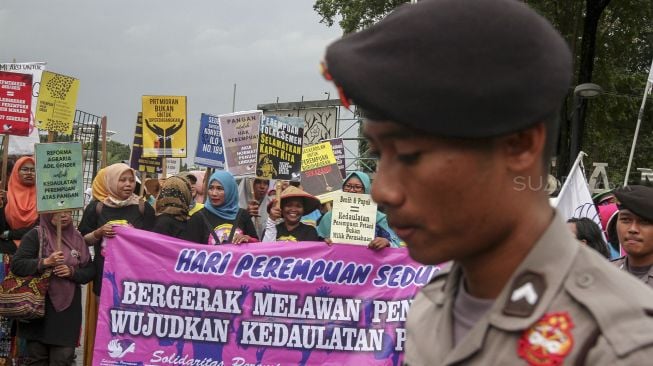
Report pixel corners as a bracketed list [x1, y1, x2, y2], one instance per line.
[325, 0, 572, 138]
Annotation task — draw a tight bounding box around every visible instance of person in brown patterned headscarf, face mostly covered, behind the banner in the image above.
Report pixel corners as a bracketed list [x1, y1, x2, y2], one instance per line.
[152, 176, 193, 238]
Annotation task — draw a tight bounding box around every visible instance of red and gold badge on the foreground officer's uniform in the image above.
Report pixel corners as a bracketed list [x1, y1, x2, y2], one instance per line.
[517, 312, 574, 366]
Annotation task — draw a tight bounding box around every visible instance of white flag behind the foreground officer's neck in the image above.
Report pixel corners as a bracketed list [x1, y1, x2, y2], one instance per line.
[554, 151, 601, 227]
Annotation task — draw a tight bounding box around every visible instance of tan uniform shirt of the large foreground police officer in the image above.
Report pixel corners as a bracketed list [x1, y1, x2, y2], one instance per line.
[404, 215, 653, 366]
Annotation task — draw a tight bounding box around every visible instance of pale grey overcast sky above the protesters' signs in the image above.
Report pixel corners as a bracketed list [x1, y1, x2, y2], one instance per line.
[0, 0, 342, 157]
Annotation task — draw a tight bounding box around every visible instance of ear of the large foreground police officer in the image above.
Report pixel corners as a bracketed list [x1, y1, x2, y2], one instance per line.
[497, 123, 546, 173]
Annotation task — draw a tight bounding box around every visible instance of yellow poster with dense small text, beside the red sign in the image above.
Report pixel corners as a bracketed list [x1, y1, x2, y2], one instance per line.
[34, 71, 79, 135]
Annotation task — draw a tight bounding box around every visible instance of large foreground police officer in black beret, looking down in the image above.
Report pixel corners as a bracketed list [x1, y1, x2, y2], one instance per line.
[323, 0, 653, 365]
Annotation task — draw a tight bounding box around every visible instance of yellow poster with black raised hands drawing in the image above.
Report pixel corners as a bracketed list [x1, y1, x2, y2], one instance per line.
[141, 95, 188, 158]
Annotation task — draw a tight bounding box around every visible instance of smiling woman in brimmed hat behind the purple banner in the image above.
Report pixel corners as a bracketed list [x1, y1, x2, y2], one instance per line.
[263, 186, 322, 242]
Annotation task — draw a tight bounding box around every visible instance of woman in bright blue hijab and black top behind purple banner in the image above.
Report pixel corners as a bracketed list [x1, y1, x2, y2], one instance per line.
[186, 171, 258, 245]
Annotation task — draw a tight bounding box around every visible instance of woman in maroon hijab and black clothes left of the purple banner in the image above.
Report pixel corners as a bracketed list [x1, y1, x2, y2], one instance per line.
[11, 211, 95, 365]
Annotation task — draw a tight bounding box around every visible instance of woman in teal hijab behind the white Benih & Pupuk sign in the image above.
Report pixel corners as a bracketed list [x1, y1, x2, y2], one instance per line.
[317, 172, 403, 250]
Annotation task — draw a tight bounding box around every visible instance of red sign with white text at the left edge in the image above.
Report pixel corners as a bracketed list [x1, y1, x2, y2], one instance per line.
[0, 71, 32, 136]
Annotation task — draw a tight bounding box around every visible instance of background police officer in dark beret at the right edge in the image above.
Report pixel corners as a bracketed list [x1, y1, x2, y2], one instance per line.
[613, 186, 653, 287]
